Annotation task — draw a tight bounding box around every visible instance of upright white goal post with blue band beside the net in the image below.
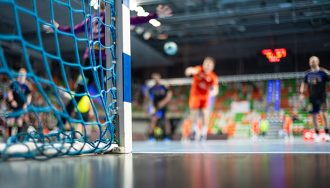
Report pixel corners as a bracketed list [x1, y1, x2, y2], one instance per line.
[106, 0, 132, 153]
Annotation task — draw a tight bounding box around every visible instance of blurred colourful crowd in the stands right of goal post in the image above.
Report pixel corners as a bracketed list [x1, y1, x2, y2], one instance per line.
[133, 79, 330, 140]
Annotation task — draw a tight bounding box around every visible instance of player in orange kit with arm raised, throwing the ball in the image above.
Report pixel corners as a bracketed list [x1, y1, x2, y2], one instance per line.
[185, 57, 219, 140]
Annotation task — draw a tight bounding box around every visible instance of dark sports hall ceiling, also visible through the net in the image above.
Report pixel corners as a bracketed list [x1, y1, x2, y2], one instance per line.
[0, 0, 330, 76]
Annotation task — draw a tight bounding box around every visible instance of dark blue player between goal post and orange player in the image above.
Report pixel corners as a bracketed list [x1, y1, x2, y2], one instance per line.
[148, 73, 172, 140]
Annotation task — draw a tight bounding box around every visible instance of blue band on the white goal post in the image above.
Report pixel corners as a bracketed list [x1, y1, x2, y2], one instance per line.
[123, 53, 132, 103]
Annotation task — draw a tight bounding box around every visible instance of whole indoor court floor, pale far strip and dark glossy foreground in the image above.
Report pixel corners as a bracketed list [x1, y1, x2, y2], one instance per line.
[0, 140, 330, 188]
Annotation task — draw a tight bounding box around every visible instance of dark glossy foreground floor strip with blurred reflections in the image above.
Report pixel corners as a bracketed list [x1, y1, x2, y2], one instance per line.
[0, 154, 330, 188]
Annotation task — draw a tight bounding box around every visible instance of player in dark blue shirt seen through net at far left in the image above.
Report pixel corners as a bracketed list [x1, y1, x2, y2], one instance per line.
[7, 68, 32, 136]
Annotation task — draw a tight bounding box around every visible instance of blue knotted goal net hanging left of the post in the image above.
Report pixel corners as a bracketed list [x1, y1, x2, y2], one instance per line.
[0, 0, 118, 159]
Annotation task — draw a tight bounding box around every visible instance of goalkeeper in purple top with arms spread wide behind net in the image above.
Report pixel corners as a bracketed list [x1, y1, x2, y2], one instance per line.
[43, 2, 172, 124]
